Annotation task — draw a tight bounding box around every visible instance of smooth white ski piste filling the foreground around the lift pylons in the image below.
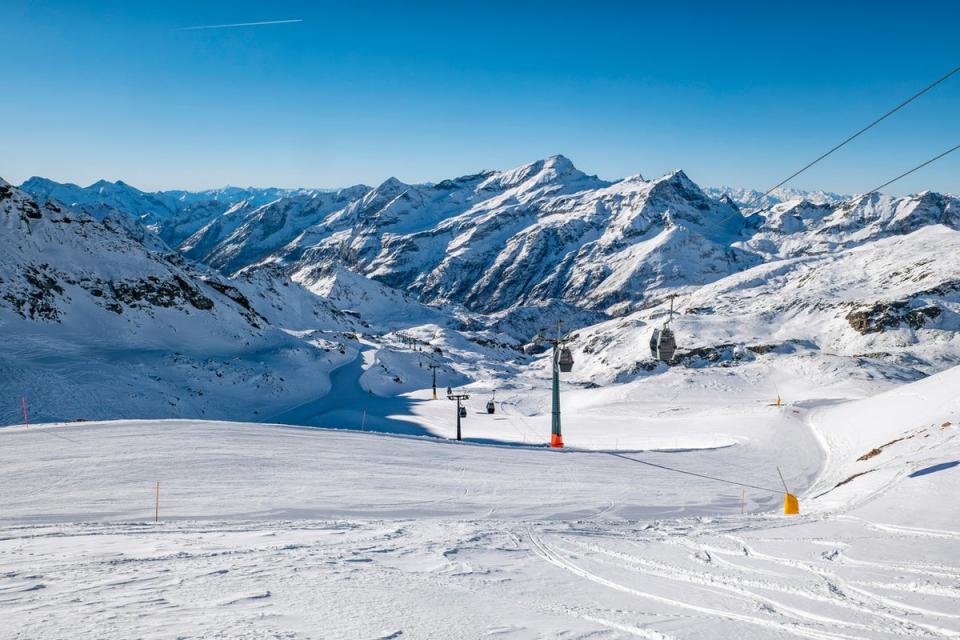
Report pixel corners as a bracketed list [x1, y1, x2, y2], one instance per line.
[0, 358, 960, 640]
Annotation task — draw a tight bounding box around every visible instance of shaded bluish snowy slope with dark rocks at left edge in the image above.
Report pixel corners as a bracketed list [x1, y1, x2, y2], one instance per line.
[0, 182, 355, 424]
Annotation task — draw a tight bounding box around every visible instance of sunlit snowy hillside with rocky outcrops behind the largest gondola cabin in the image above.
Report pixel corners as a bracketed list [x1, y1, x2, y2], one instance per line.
[572, 225, 960, 384]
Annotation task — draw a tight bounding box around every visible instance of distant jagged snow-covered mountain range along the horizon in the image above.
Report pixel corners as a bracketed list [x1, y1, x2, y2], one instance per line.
[23, 156, 956, 315]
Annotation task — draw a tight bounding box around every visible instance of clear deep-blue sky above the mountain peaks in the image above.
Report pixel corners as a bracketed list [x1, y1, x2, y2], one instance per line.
[0, 0, 960, 193]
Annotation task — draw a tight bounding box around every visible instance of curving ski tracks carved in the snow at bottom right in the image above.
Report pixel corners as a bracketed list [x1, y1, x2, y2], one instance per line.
[527, 520, 960, 640]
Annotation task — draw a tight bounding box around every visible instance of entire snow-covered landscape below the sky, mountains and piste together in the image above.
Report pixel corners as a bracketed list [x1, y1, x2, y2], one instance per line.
[0, 156, 960, 640]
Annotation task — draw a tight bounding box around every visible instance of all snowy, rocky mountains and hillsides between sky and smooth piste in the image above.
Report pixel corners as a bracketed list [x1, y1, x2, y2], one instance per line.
[7, 156, 960, 421]
